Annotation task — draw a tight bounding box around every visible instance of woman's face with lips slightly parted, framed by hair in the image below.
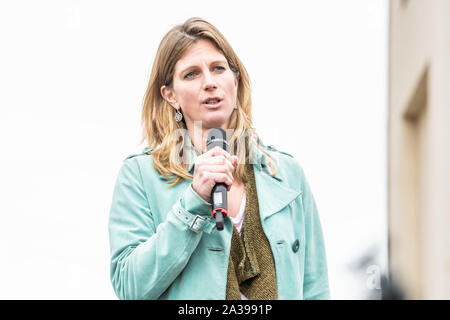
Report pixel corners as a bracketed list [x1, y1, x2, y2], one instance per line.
[161, 39, 239, 129]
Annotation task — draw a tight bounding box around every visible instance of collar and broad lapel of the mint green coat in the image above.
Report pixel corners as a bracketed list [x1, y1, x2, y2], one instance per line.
[180, 134, 301, 219]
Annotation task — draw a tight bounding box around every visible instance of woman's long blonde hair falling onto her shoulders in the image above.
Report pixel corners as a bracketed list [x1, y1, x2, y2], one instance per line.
[141, 17, 277, 187]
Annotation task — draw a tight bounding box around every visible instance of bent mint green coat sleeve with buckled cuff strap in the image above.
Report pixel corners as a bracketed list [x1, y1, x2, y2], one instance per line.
[108, 158, 211, 299]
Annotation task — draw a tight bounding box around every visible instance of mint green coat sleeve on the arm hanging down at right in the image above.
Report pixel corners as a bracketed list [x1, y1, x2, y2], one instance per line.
[299, 167, 330, 300]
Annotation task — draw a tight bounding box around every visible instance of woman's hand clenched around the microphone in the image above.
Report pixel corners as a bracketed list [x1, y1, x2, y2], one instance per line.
[192, 147, 238, 203]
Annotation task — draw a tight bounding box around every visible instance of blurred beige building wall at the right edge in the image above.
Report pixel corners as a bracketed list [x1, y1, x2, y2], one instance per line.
[388, 0, 450, 299]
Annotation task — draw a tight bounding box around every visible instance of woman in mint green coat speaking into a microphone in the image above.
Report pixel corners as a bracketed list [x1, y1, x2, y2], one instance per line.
[109, 18, 329, 299]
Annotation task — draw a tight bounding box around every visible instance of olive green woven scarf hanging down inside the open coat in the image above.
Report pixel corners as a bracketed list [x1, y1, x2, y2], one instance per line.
[226, 164, 278, 300]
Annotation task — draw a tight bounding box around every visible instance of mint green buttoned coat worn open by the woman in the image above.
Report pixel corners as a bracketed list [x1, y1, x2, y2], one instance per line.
[109, 135, 329, 299]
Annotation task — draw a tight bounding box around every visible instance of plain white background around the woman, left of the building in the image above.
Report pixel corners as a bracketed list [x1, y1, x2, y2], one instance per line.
[0, 0, 388, 299]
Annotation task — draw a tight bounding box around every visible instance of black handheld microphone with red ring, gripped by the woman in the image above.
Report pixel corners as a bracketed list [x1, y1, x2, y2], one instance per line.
[206, 128, 228, 231]
